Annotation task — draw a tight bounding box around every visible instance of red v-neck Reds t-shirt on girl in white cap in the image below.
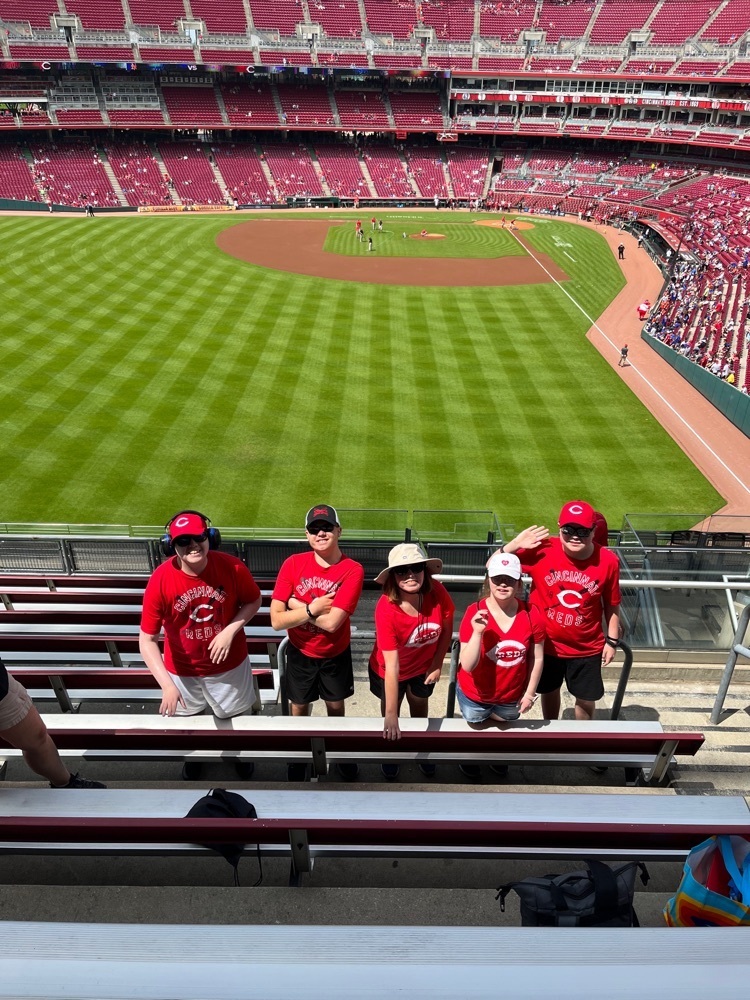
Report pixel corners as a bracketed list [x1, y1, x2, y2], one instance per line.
[457, 598, 544, 705]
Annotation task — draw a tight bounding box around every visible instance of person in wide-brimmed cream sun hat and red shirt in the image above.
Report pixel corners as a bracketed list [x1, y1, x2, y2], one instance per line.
[370, 542, 455, 778]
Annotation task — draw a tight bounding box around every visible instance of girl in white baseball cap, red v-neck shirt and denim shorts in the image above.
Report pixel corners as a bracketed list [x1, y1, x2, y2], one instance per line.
[456, 552, 545, 777]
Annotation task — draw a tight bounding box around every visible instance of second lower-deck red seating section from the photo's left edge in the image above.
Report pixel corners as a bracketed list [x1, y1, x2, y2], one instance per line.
[29, 139, 120, 207]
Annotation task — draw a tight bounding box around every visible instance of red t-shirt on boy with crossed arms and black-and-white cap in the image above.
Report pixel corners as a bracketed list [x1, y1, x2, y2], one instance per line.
[271, 552, 365, 660]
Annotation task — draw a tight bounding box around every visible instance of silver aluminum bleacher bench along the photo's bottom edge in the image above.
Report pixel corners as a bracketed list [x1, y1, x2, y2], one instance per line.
[0, 921, 750, 1000]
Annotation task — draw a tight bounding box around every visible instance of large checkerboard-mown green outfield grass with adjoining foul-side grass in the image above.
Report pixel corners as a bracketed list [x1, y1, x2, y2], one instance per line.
[0, 213, 720, 527]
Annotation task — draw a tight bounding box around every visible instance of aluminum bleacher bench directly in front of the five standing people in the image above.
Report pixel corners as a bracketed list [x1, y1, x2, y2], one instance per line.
[0, 714, 704, 784]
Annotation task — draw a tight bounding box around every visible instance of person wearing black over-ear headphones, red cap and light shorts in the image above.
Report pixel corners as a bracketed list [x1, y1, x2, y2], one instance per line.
[140, 510, 261, 719]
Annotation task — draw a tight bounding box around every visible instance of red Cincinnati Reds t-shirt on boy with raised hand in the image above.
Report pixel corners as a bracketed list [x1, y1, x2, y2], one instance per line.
[516, 538, 620, 657]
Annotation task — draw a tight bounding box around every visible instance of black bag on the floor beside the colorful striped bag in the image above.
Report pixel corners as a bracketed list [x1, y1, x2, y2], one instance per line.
[495, 860, 649, 927]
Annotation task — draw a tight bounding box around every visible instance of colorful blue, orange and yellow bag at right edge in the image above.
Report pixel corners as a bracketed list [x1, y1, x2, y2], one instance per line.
[664, 836, 750, 927]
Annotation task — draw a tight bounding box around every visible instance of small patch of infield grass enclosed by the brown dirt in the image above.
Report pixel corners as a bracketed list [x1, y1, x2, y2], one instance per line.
[323, 221, 526, 259]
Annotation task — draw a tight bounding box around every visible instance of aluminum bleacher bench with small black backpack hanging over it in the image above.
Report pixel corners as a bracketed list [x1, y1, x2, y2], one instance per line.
[0, 788, 750, 878]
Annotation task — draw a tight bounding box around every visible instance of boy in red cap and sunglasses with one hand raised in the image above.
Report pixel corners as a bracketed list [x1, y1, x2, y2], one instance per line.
[504, 500, 620, 720]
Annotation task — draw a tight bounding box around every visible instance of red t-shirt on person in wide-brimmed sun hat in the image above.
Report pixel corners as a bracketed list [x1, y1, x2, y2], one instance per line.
[370, 580, 455, 681]
